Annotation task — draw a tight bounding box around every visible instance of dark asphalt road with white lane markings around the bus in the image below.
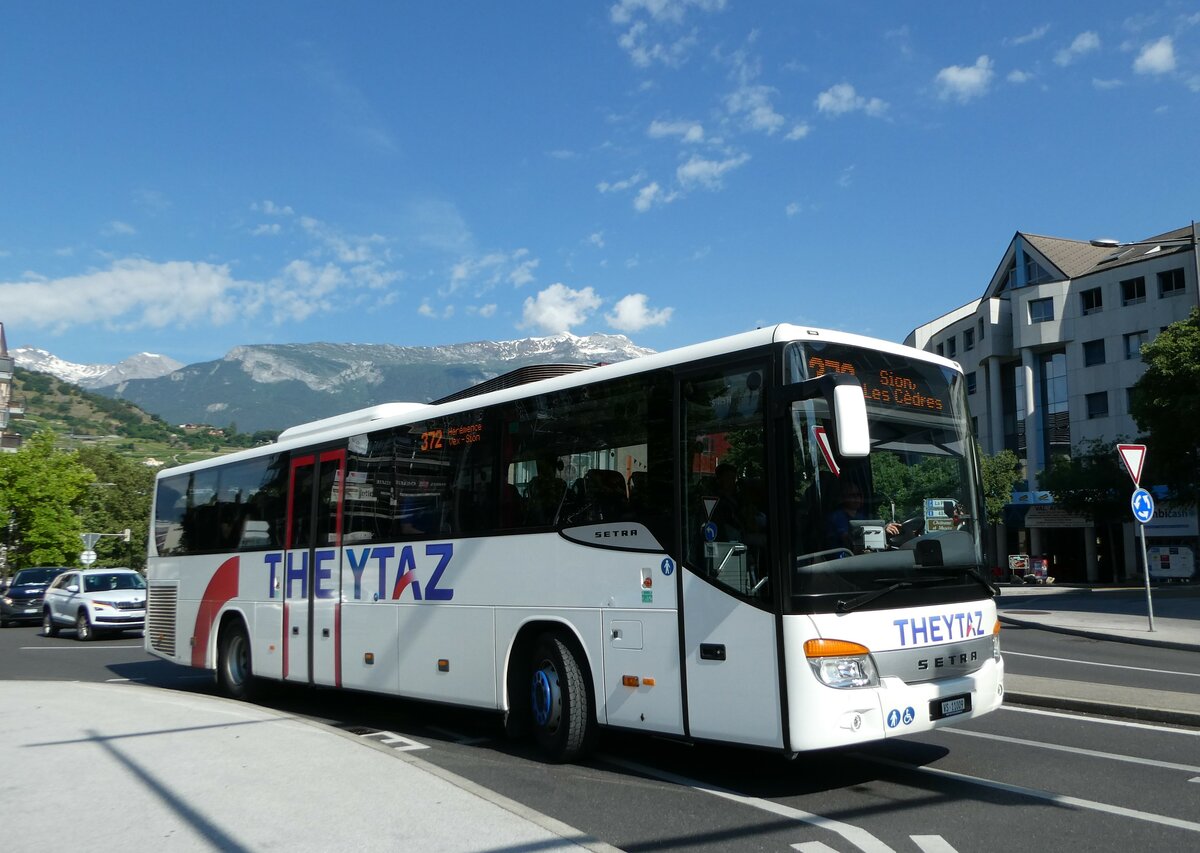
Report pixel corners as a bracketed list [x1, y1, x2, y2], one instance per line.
[0, 626, 1200, 853]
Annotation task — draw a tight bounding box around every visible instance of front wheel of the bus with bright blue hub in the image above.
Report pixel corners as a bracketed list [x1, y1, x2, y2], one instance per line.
[529, 633, 594, 762]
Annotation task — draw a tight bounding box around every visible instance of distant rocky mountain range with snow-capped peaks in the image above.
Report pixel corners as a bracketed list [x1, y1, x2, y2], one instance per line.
[10, 332, 653, 432]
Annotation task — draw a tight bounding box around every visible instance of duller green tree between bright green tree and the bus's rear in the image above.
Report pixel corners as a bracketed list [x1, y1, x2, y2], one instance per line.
[78, 445, 154, 569]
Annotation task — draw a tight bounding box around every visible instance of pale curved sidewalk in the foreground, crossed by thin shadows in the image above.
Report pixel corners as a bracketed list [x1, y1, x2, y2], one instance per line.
[0, 681, 613, 853]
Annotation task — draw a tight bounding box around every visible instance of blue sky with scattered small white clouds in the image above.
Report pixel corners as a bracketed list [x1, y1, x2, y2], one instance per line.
[0, 0, 1200, 362]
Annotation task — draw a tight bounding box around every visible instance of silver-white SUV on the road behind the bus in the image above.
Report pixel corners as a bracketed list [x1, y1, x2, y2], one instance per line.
[42, 569, 146, 641]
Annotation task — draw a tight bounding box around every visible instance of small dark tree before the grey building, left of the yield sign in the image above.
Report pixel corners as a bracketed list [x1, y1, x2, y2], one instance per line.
[1038, 439, 1132, 581]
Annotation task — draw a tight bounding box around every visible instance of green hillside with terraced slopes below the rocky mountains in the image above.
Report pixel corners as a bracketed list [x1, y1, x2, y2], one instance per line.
[11, 367, 275, 465]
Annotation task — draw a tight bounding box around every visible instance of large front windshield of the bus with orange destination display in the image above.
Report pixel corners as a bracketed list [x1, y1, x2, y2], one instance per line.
[785, 343, 989, 612]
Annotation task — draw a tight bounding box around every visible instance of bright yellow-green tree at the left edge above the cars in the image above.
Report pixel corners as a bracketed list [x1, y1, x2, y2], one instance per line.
[0, 431, 96, 571]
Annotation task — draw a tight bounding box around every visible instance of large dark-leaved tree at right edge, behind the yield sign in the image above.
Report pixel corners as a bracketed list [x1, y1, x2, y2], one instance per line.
[1129, 308, 1200, 501]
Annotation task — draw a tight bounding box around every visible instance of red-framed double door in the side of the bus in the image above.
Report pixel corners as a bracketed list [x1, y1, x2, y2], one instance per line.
[282, 450, 346, 686]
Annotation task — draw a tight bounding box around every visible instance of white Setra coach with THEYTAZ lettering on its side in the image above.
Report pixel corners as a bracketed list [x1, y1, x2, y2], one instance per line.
[145, 325, 1003, 761]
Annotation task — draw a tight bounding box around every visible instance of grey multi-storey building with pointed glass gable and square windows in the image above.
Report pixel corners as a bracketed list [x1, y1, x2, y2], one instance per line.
[905, 223, 1200, 582]
